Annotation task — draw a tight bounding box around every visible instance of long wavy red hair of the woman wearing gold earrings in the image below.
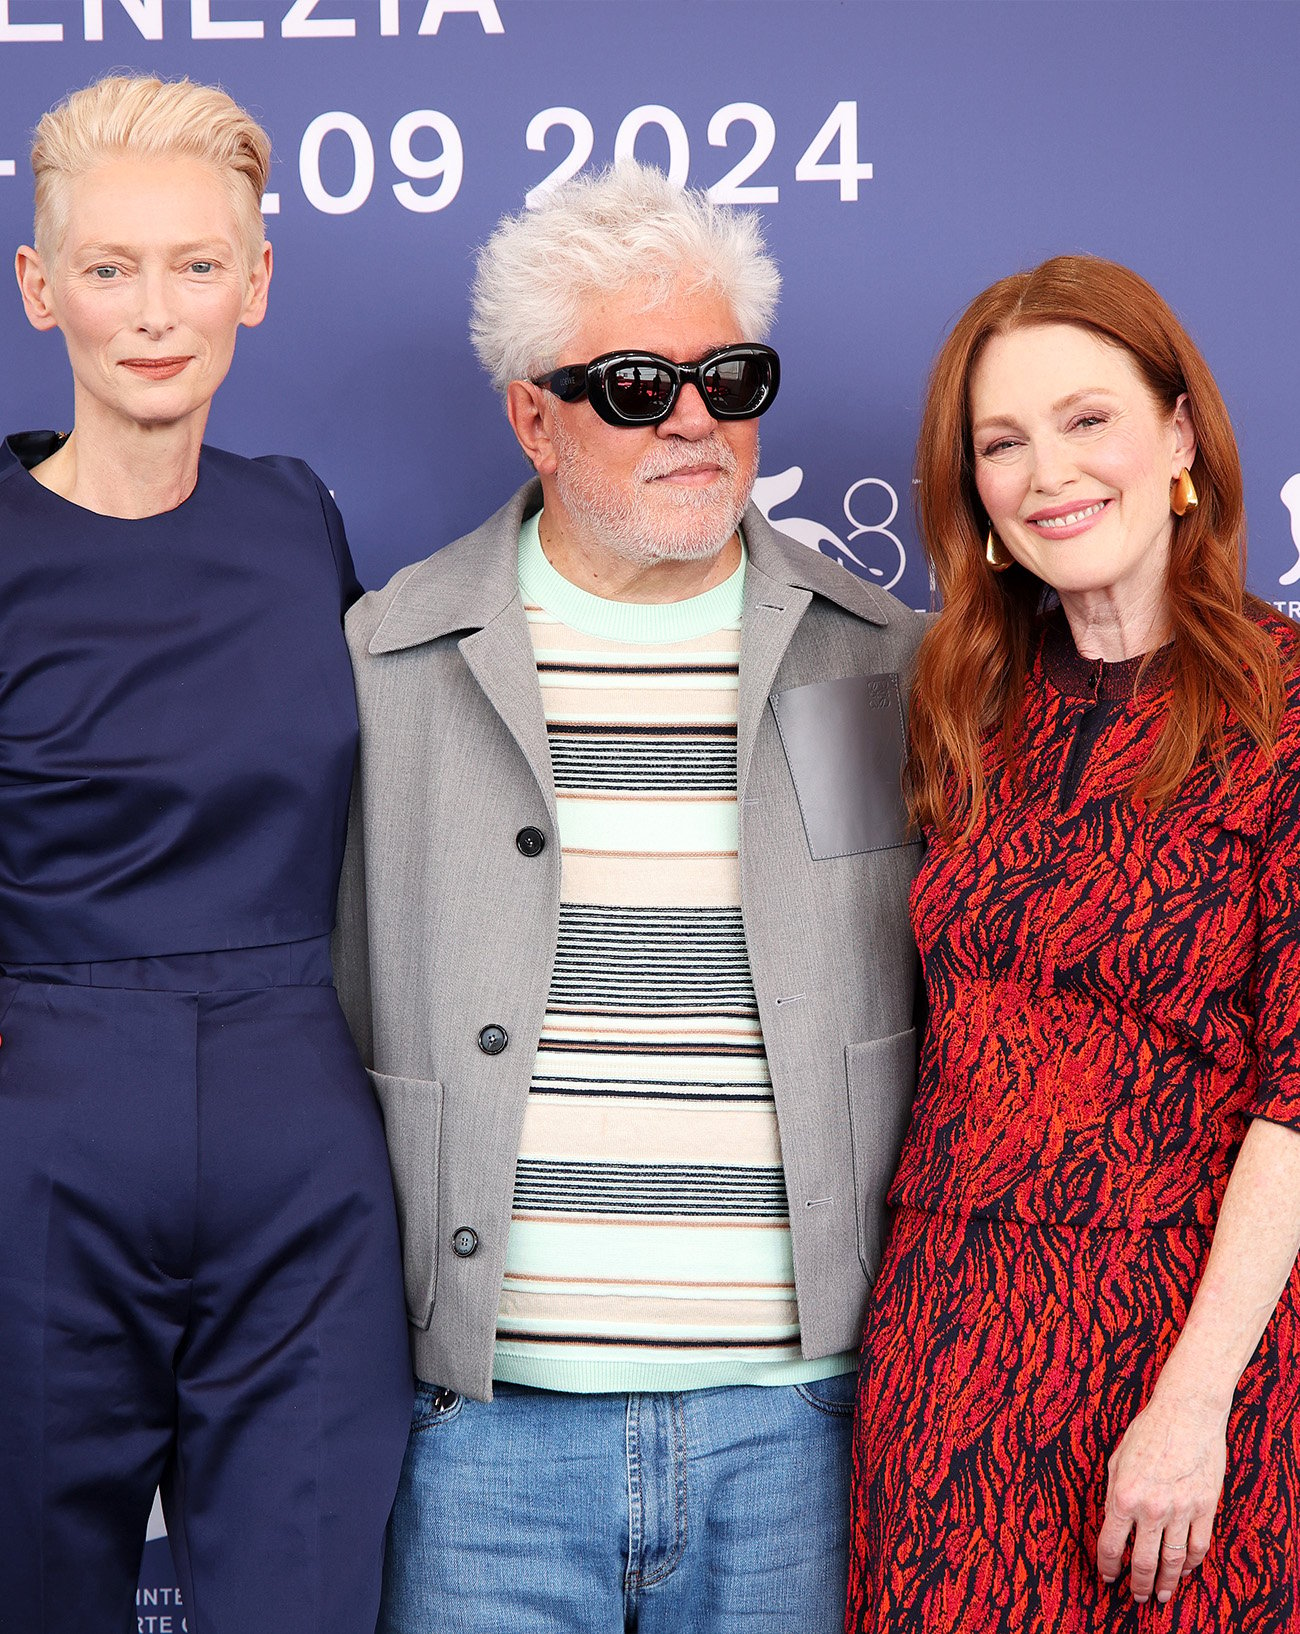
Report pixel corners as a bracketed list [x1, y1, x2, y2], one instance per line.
[908, 255, 1284, 835]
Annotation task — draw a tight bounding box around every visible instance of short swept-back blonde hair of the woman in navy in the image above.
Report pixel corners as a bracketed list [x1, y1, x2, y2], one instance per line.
[31, 75, 271, 266]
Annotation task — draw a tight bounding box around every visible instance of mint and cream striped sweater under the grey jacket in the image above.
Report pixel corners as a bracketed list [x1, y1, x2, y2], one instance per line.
[493, 516, 853, 1391]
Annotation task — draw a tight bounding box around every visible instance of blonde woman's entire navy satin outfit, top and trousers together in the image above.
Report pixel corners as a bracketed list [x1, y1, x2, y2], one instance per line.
[0, 433, 412, 1634]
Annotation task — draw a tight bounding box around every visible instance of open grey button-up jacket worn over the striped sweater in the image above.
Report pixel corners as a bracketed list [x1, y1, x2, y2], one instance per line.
[335, 484, 923, 1400]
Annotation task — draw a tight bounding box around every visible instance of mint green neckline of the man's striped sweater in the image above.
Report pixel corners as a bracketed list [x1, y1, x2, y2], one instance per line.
[519, 511, 748, 645]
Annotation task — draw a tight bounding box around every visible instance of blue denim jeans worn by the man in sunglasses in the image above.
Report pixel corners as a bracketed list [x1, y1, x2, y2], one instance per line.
[379, 1373, 854, 1634]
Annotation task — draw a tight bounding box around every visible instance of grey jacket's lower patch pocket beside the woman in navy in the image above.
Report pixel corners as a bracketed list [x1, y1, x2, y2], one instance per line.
[369, 1072, 443, 1328]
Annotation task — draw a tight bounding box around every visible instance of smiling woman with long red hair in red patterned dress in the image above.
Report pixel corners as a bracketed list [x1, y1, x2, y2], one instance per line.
[848, 257, 1300, 1634]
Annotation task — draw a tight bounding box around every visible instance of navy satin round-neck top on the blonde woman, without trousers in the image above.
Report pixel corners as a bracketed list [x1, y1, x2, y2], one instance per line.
[0, 433, 359, 962]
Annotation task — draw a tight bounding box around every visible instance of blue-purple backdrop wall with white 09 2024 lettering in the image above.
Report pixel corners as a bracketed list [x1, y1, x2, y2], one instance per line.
[0, 0, 1300, 1614]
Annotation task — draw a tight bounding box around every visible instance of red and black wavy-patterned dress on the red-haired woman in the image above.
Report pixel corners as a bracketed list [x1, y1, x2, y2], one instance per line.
[846, 618, 1300, 1634]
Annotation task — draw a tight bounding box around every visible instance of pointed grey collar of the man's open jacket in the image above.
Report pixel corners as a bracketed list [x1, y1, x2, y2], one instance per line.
[369, 479, 892, 654]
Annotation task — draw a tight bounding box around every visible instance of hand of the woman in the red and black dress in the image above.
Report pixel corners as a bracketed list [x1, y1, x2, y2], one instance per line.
[1097, 1386, 1228, 1603]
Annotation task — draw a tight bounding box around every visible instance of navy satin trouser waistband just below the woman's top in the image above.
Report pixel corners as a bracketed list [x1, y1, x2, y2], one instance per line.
[0, 936, 333, 993]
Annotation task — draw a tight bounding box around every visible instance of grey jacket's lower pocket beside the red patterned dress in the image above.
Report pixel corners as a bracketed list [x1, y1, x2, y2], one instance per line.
[844, 1028, 916, 1281]
